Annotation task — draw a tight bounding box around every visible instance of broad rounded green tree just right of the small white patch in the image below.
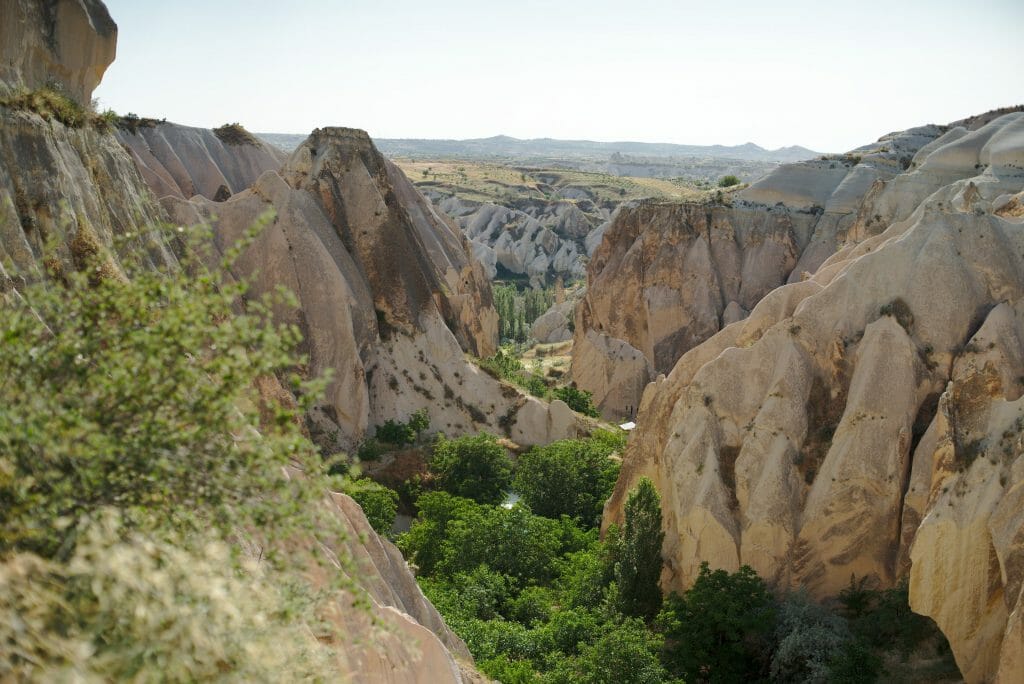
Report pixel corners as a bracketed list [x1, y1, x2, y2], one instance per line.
[512, 439, 618, 527]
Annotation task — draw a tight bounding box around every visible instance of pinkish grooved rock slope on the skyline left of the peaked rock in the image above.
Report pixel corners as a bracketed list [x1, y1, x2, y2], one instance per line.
[117, 120, 287, 201]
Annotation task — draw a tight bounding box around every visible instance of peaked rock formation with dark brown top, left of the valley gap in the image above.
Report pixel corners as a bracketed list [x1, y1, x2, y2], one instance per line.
[163, 129, 583, 448]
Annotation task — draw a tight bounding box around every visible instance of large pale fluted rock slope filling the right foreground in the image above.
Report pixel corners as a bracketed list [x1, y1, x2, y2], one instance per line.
[598, 113, 1024, 682]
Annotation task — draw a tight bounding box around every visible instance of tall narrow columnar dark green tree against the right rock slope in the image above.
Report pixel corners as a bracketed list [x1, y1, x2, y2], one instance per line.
[615, 477, 665, 618]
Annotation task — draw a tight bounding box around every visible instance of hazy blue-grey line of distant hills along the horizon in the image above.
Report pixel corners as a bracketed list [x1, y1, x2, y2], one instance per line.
[259, 133, 818, 163]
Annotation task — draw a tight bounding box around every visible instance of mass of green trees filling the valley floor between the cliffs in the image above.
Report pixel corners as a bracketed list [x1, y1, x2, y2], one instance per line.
[398, 433, 956, 684]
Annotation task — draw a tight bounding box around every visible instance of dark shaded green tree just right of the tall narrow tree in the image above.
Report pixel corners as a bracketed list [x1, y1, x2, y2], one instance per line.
[658, 563, 774, 682]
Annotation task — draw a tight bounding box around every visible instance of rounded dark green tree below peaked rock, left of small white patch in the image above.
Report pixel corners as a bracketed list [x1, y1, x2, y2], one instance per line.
[428, 432, 512, 504]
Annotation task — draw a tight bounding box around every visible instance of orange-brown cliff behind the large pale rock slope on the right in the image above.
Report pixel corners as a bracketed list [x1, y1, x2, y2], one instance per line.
[572, 120, 962, 418]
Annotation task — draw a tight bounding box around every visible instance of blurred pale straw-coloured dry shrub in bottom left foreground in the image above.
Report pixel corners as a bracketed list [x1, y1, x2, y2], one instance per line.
[0, 515, 334, 682]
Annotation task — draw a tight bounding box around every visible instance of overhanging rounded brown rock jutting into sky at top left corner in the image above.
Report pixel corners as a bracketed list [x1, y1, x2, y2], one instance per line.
[0, 0, 118, 104]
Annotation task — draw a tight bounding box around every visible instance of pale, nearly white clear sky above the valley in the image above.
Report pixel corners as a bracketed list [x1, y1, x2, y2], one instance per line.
[95, 0, 1024, 152]
